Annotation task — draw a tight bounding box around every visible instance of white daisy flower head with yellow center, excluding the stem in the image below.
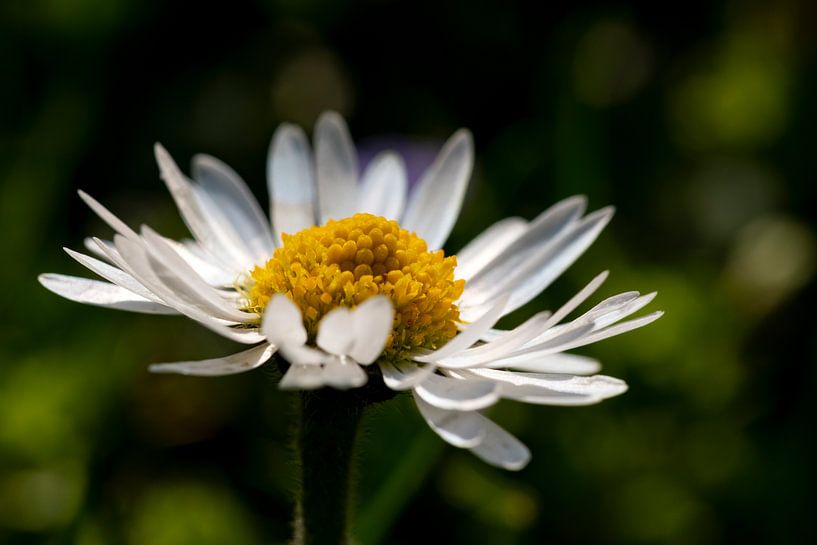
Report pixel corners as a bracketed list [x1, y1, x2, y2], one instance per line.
[40, 112, 662, 470]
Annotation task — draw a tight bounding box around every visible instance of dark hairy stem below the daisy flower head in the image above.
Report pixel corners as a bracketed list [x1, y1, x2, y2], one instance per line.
[293, 388, 366, 545]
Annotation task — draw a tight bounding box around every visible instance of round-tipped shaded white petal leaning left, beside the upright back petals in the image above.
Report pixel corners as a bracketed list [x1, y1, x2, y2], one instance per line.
[193, 155, 275, 263]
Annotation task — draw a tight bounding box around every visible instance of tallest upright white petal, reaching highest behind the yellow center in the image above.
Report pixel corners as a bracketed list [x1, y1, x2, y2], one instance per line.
[314, 112, 357, 224]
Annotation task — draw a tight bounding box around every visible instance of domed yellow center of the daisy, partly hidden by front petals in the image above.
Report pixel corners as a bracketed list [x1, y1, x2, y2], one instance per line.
[245, 214, 465, 359]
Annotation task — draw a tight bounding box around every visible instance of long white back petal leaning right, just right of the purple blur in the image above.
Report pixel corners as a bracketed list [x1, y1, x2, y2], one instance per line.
[401, 129, 474, 250]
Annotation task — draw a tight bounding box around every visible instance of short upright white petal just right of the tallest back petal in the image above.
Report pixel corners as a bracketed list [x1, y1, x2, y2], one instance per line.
[357, 151, 408, 220]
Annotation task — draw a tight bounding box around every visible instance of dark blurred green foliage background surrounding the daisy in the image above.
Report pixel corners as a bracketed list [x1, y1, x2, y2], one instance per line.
[0, 0, 817, 545]
